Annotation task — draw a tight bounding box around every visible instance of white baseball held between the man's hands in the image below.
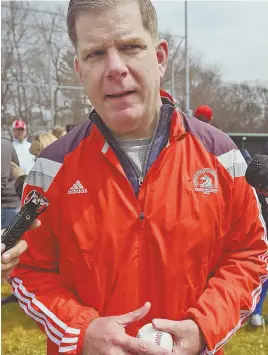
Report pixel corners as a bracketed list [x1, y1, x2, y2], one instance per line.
[137, 323, 173, 351]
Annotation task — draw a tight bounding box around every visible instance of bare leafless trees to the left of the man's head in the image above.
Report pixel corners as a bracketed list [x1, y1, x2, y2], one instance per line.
[1, 2, 85, 134]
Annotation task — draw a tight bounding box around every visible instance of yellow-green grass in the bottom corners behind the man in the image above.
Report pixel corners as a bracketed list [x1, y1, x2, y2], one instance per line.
[1, 284, 268, 355]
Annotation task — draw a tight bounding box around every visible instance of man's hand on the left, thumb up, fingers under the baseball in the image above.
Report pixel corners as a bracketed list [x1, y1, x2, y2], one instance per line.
[82, 302, 171, 355]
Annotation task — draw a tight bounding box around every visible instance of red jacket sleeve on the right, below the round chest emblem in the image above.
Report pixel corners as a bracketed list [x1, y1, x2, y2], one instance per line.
[187, 154, 268, 355]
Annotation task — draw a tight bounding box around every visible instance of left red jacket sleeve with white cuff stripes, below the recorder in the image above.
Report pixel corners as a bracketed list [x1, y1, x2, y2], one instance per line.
[11, 162, 99, 355]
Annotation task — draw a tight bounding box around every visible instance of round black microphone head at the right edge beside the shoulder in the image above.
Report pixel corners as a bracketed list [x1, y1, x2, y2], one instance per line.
[245, 155, 268, 196]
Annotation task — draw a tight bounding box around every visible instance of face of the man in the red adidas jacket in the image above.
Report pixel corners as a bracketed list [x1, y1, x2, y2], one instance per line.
[75, 3, 168, 138]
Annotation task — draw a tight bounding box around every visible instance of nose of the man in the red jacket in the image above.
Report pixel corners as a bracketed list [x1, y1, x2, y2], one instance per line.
[105, 49, 128, 80]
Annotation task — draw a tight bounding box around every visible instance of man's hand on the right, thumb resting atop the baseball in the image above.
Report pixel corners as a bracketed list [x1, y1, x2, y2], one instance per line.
[152, 319, 206, 355]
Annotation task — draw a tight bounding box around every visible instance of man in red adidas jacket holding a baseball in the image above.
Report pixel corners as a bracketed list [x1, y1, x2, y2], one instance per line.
[5, 0, 267, 355]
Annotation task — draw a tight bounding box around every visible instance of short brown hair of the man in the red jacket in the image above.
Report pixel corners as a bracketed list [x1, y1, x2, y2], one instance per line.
[67, 0, 158, 48]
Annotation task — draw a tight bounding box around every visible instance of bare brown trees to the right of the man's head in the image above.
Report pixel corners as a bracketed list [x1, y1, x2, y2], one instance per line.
[159, 33, 268, 132]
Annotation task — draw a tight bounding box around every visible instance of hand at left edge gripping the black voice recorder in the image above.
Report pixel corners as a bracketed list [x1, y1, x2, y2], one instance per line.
[1, 219, 41, 279]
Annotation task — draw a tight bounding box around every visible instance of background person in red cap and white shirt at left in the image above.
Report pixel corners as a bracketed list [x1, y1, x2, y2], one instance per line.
[12, 120, 35, 174]
